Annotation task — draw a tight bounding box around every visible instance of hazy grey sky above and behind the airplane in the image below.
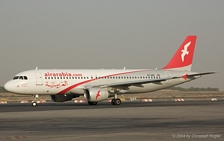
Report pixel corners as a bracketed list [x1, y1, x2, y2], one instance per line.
[0, 0, 224, 90]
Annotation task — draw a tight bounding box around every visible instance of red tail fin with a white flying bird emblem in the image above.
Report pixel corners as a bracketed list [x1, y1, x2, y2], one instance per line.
[163, 36, 196, 71]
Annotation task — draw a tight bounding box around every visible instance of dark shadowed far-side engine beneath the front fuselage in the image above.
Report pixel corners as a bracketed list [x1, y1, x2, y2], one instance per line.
[51, 94, 79, 102]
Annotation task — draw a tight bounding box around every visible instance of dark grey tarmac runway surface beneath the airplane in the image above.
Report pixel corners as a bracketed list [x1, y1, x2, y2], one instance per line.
[0, 101, 224, 141]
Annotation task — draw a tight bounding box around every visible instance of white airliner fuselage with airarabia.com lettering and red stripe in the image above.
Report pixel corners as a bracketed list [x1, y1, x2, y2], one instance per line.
[5, 69, 198, 95]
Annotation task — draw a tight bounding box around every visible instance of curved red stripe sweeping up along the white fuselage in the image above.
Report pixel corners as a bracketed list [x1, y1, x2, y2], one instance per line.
[58, 70, 148, 94]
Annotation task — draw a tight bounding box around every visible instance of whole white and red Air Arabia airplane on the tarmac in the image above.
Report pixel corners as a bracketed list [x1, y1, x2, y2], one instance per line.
[4, 36, 215, 107]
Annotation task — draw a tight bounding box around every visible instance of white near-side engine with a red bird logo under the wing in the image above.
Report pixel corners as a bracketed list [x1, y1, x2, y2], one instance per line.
[84, 88, 110, 102]
